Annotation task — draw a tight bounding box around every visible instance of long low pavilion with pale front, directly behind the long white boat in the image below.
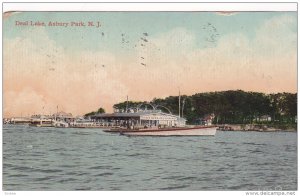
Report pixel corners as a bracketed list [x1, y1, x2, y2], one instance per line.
[91, 110, 186, 128]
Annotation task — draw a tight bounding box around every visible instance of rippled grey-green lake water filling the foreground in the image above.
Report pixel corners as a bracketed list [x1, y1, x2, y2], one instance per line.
[3, 125, 297, 191]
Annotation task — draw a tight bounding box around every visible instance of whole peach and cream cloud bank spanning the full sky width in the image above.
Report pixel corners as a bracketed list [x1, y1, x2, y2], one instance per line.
[3, 15, 297, 116]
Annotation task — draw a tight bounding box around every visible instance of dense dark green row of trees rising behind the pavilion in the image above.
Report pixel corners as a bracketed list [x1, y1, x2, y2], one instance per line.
[114, 90, 297, 124]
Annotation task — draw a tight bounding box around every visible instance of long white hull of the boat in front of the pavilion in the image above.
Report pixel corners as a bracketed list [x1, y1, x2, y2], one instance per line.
[121, 127, 217, 136]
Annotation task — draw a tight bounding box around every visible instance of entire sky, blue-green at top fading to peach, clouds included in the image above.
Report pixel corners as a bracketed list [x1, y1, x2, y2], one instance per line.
[3, 12, 297, 117]
